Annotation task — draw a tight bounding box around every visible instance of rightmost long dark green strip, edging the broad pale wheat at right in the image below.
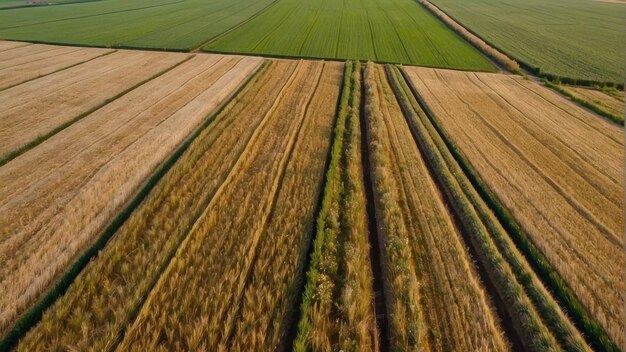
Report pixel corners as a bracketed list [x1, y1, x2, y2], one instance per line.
[401, 66, 620, 351]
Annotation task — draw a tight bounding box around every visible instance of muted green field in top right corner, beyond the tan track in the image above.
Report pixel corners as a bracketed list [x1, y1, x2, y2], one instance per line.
[432, 0, 626, 83]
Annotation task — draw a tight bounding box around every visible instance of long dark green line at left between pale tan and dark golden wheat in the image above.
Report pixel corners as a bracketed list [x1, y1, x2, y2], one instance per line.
[0, 55, 265, 352]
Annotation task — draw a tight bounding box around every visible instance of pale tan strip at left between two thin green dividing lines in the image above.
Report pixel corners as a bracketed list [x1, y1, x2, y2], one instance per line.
[0, 51, 186, 156]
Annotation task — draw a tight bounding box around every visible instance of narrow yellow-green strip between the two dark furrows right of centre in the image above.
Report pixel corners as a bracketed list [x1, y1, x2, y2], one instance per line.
[387, 66, 590, 351]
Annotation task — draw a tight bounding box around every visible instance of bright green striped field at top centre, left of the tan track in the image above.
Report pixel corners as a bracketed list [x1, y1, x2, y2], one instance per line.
[204, 0, 493, 70]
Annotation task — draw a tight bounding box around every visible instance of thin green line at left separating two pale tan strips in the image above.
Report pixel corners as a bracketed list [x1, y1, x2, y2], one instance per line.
[0, 51, 194, 167]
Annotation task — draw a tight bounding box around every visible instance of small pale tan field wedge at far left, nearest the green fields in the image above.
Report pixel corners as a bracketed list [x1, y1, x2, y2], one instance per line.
[0, 44, 113, 90]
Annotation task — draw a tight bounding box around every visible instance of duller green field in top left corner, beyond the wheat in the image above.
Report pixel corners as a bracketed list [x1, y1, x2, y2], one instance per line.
[0, 0, 272, 50]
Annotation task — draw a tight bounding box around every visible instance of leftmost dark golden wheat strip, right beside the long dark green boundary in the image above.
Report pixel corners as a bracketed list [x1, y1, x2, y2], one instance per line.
[18, 61, 296, 351]
